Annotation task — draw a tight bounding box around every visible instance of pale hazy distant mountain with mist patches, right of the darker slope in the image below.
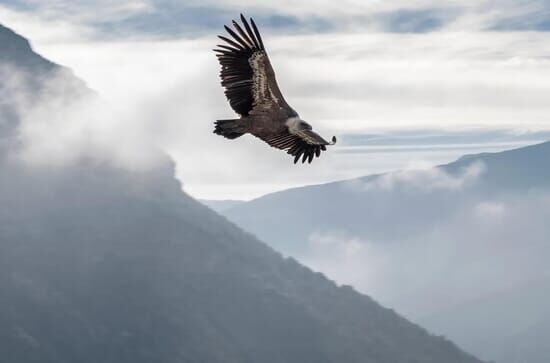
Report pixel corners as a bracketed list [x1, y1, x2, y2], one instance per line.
[223, 142, 550, 363]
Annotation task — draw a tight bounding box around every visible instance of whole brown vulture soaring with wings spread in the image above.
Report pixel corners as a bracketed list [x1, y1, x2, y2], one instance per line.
[214, 14, 336, 164]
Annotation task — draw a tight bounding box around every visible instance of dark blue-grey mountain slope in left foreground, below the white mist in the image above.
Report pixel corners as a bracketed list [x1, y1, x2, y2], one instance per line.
[0, 24, 488, 363]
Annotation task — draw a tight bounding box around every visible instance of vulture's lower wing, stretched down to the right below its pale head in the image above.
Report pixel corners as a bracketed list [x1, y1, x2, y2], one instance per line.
[262, 130, 336, 164]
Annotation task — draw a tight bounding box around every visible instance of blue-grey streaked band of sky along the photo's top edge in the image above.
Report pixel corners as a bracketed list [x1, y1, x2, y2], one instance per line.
[0, 0, 550, 37]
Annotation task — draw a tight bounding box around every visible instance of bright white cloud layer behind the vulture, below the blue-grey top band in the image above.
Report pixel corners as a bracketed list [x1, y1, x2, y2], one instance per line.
[0, 2, 550, 199]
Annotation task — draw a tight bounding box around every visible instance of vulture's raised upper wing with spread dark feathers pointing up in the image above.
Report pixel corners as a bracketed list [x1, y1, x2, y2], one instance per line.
[214, 14, 293, 116]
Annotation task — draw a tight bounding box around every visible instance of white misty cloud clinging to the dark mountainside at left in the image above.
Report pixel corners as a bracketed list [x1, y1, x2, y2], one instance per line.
[0, 61, 166, 169]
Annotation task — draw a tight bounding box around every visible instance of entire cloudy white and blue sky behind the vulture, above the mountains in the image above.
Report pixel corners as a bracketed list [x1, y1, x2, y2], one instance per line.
[0, 0, 550, 199]
